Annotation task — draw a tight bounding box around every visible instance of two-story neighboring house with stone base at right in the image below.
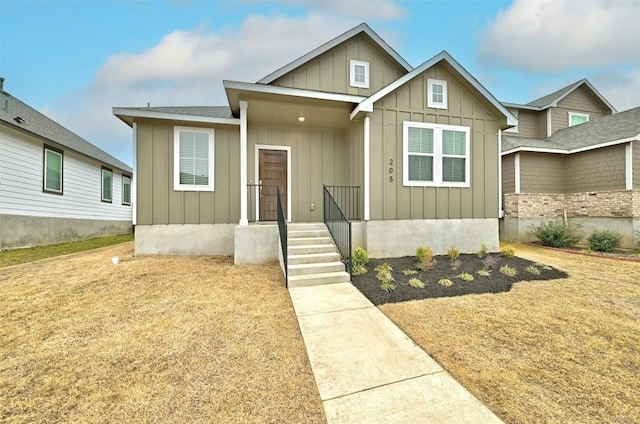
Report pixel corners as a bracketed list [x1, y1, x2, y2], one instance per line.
[501, 80, 640, 247]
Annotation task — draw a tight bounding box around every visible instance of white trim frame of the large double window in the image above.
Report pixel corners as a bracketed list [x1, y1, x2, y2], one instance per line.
[402, 121, 471, 187]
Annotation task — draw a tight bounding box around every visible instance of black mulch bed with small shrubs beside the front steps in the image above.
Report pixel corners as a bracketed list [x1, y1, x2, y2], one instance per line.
[352, 254, 567, 305]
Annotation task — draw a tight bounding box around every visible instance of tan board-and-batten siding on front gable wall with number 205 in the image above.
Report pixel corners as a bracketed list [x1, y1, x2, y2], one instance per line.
[370, 64, 505, 220]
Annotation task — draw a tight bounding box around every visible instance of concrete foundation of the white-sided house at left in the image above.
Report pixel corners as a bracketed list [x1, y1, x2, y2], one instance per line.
[0, 215, 133, 249]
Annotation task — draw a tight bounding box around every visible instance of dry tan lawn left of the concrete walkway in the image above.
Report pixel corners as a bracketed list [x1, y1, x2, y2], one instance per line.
[0, 243, 325, 423]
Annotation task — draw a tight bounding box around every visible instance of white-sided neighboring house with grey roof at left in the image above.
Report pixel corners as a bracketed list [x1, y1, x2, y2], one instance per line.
[0, 78, 133, 249]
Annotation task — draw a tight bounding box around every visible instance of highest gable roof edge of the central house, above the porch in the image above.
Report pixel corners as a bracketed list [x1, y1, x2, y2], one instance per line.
[258, 23, 413, 84]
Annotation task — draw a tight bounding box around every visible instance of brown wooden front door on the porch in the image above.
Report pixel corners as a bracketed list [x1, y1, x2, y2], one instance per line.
[259, 150, 287, 221]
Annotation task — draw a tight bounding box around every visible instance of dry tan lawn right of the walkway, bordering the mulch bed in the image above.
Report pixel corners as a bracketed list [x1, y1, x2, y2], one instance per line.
[380, 246, 640, 424]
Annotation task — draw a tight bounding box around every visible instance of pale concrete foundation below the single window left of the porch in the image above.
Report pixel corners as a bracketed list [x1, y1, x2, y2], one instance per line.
[135, 224, 236, 255]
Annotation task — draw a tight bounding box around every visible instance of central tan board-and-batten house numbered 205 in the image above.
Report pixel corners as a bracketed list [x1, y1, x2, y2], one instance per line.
[113, 24, 517, 263]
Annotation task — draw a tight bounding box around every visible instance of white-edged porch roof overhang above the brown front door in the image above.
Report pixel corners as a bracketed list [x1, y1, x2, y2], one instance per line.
[222, 81, 366, 116]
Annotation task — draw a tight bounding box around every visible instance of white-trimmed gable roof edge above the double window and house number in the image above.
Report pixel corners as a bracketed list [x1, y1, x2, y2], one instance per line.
[351, 50, 518, 126]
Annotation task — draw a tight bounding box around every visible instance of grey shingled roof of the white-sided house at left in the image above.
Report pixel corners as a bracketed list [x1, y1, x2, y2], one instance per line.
[0, 90, 133, 172]
